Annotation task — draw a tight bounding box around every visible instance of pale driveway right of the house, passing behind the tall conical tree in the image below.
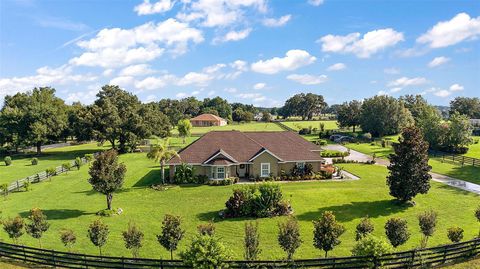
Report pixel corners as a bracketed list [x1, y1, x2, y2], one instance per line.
[323, 144, 480, 195]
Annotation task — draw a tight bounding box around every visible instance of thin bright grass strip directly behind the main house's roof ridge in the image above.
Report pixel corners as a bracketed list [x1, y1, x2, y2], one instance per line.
[172, 122, 283, 136]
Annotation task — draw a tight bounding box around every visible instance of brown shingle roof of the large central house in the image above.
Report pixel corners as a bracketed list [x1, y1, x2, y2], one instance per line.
[169, 131, 322, 164]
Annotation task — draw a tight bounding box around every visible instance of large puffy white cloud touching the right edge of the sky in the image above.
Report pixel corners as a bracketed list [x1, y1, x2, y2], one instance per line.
[417, 13, 480, 48]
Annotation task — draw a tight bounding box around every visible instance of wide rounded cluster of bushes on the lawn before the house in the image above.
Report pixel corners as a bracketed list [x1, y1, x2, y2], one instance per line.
[223, 183, 292, 218]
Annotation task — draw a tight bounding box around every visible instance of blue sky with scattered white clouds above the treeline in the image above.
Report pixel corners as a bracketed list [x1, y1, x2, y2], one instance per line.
[0, 0, 480, 106]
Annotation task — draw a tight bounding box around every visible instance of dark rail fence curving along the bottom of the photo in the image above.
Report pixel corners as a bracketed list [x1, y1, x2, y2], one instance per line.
[0, 238, 480, 269]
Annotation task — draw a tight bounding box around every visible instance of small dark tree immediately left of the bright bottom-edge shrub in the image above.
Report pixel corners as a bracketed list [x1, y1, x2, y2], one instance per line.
[157, 214, 185, 260]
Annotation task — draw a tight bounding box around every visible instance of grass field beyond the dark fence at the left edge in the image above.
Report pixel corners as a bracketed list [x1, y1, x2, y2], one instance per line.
[0, 143, 109, 184]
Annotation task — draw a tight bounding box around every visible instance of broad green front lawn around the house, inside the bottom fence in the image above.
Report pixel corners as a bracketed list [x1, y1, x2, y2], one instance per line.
[0, 153, 480, 259]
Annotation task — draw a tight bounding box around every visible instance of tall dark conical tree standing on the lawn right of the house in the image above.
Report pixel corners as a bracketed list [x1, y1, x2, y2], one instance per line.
[387, 127, 432, 203]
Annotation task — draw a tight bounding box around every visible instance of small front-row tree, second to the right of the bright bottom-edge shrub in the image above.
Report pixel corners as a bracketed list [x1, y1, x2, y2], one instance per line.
[278, 217, 302, 260]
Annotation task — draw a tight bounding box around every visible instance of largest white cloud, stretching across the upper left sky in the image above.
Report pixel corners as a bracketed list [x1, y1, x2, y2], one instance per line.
[70, 18, 204, 68]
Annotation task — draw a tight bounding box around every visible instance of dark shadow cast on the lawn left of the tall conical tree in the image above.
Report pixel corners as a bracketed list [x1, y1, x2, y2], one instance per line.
[297, 200, 411, 222]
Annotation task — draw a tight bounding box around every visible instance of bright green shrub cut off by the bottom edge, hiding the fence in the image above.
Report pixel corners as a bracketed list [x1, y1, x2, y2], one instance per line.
[180, 234, 231, 269]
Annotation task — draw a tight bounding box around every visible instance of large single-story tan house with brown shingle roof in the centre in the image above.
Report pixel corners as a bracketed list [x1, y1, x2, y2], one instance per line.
[168, 131, 324, 179]
